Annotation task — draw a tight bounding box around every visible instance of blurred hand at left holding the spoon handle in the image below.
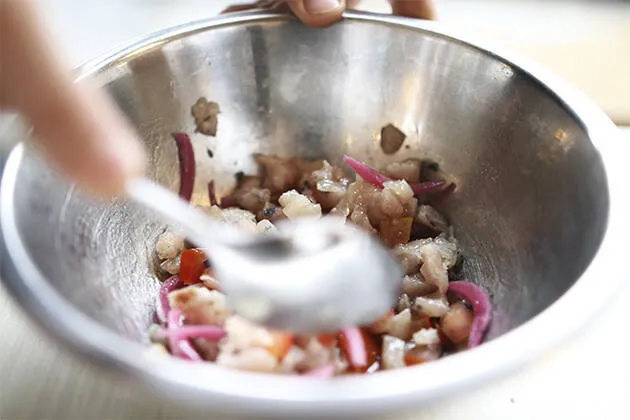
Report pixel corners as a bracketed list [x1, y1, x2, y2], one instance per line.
[0, 0, 144, 195]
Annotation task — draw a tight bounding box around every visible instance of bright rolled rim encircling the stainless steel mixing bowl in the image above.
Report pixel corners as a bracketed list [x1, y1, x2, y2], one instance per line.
[0, 11, 630, 415]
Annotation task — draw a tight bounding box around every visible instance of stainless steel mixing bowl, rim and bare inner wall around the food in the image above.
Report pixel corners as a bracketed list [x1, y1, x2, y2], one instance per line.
[0, 12, 630, 417]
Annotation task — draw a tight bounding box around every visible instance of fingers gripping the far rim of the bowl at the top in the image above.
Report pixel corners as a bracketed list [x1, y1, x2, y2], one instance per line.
[224, 0, 435, 27]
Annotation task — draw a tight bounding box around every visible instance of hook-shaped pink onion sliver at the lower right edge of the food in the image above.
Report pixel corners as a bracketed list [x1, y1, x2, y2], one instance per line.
[448, 281, 492, 348]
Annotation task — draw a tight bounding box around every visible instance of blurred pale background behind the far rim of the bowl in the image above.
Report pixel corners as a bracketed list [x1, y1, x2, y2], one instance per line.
[42, 0, 630, 124]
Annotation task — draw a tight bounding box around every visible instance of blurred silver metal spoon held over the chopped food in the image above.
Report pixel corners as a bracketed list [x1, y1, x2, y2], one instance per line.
[127, 179, 402, 334]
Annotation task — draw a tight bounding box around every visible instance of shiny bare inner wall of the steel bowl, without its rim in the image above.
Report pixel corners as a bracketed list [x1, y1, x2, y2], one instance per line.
[8, 15, 608, 340]
